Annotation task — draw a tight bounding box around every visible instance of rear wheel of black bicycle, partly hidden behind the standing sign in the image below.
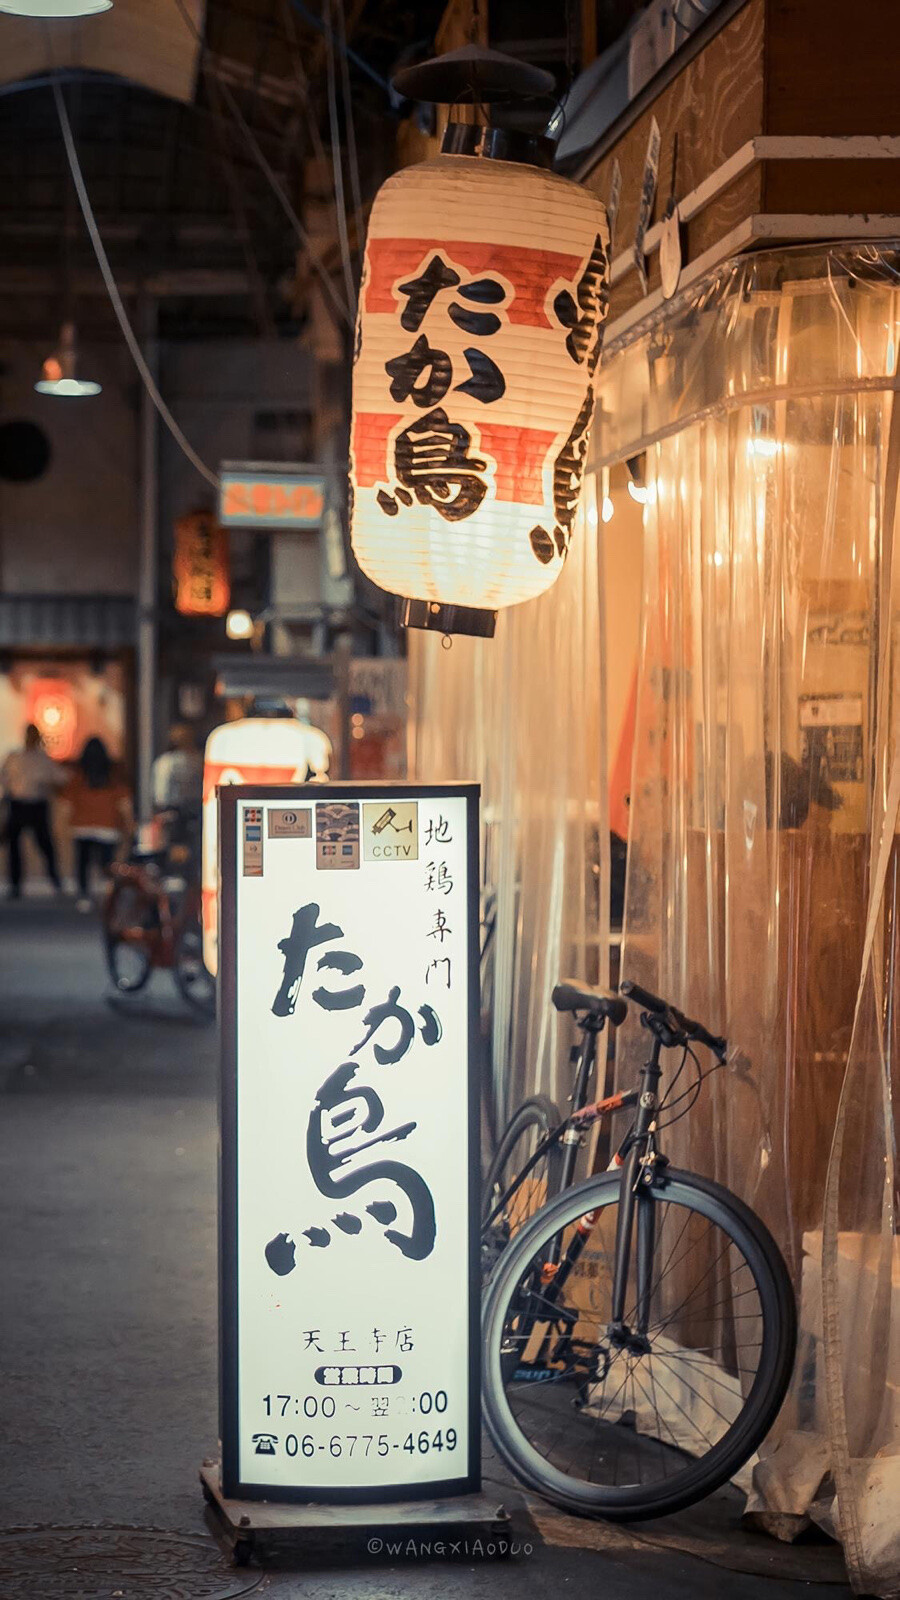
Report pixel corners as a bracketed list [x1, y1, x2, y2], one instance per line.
[482, 1094, 562, 1282]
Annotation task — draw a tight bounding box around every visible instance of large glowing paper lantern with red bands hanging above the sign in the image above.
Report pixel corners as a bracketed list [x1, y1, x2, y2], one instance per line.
[351, 123, 609, 634]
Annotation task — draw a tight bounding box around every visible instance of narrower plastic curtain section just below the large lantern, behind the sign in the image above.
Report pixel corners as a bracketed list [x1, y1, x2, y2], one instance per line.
[408, 477, 609, 1142]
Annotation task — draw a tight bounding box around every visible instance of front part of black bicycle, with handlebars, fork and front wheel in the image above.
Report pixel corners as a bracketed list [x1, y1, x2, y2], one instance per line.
[484, 982, 796, 1522]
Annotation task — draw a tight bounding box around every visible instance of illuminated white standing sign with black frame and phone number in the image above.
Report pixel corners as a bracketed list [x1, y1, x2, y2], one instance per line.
[219, 784, 480, 1501]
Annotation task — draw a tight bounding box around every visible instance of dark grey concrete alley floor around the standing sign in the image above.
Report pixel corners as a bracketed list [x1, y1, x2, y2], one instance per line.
[0, 899, 849, 1600]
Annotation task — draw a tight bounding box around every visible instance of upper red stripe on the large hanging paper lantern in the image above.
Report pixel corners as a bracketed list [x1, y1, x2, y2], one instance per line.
[364, 237, 583, 328]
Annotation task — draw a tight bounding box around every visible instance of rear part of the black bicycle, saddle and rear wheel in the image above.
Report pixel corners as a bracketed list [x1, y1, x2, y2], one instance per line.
[482, 979, 628, 1282]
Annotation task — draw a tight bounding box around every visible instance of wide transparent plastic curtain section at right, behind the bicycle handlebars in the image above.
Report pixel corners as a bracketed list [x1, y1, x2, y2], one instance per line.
[597, 246, 900, 1595]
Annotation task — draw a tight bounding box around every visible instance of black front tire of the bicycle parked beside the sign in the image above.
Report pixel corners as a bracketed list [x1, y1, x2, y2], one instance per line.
[482, 1168, 796, 1522]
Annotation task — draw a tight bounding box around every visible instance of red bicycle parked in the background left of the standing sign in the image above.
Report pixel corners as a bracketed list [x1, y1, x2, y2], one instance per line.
[102, 811, 216, 1021]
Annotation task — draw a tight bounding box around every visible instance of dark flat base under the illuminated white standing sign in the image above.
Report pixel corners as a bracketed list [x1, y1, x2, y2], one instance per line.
[200, 1461, 509, 1566]
